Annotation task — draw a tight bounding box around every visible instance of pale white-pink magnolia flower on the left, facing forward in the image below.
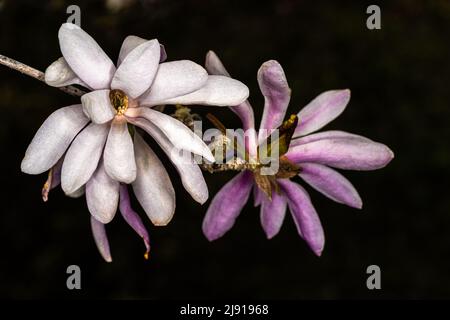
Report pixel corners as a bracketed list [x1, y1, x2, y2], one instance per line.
[21, 23, 248, 260]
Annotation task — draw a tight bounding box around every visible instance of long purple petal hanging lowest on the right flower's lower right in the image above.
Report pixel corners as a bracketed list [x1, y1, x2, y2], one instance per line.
[278, 179, 325, 256]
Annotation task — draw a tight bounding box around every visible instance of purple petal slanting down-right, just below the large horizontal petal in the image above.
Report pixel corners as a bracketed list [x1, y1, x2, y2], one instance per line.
[299, 163, 362, 209]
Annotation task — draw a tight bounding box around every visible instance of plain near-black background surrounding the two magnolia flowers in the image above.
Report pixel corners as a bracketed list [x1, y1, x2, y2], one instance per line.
[0, 0, 450, 299]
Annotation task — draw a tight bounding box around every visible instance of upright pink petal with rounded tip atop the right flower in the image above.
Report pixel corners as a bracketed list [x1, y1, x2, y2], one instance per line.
[258, 60, 291, 142]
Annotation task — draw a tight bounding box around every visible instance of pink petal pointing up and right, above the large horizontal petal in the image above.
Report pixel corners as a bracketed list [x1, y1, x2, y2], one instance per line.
[294, 89, 350, 137]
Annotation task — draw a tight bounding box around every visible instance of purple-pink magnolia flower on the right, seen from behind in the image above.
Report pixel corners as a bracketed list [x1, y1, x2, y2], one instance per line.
[203, 52, 394, 255]
